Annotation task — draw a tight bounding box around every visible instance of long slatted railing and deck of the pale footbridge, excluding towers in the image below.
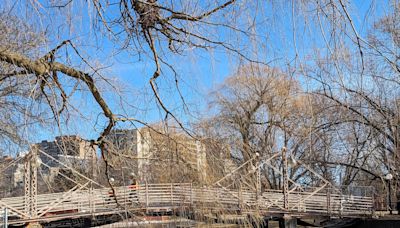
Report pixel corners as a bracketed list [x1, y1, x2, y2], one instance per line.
[0, 182, 373, 224]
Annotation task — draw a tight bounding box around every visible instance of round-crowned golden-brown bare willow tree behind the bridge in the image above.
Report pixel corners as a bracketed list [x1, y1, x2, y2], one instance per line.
[207, 65, 326, 188]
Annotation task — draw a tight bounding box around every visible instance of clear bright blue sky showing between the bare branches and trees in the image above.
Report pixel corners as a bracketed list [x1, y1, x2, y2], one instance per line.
[0, 0, 388, 147]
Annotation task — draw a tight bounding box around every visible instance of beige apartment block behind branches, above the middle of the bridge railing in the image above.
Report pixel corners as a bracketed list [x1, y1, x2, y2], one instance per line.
[107, 126, 207, 182]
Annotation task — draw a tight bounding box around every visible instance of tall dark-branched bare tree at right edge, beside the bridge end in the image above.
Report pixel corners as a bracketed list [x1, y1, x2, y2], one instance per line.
[306, 1, 400, 208]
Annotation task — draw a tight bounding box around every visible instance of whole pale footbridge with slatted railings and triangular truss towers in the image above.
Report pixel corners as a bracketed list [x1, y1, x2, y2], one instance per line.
[0, 149, 374, 224]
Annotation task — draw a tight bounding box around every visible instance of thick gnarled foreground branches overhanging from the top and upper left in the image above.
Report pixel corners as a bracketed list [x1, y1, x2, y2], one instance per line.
[0, 0, 260, 189]
